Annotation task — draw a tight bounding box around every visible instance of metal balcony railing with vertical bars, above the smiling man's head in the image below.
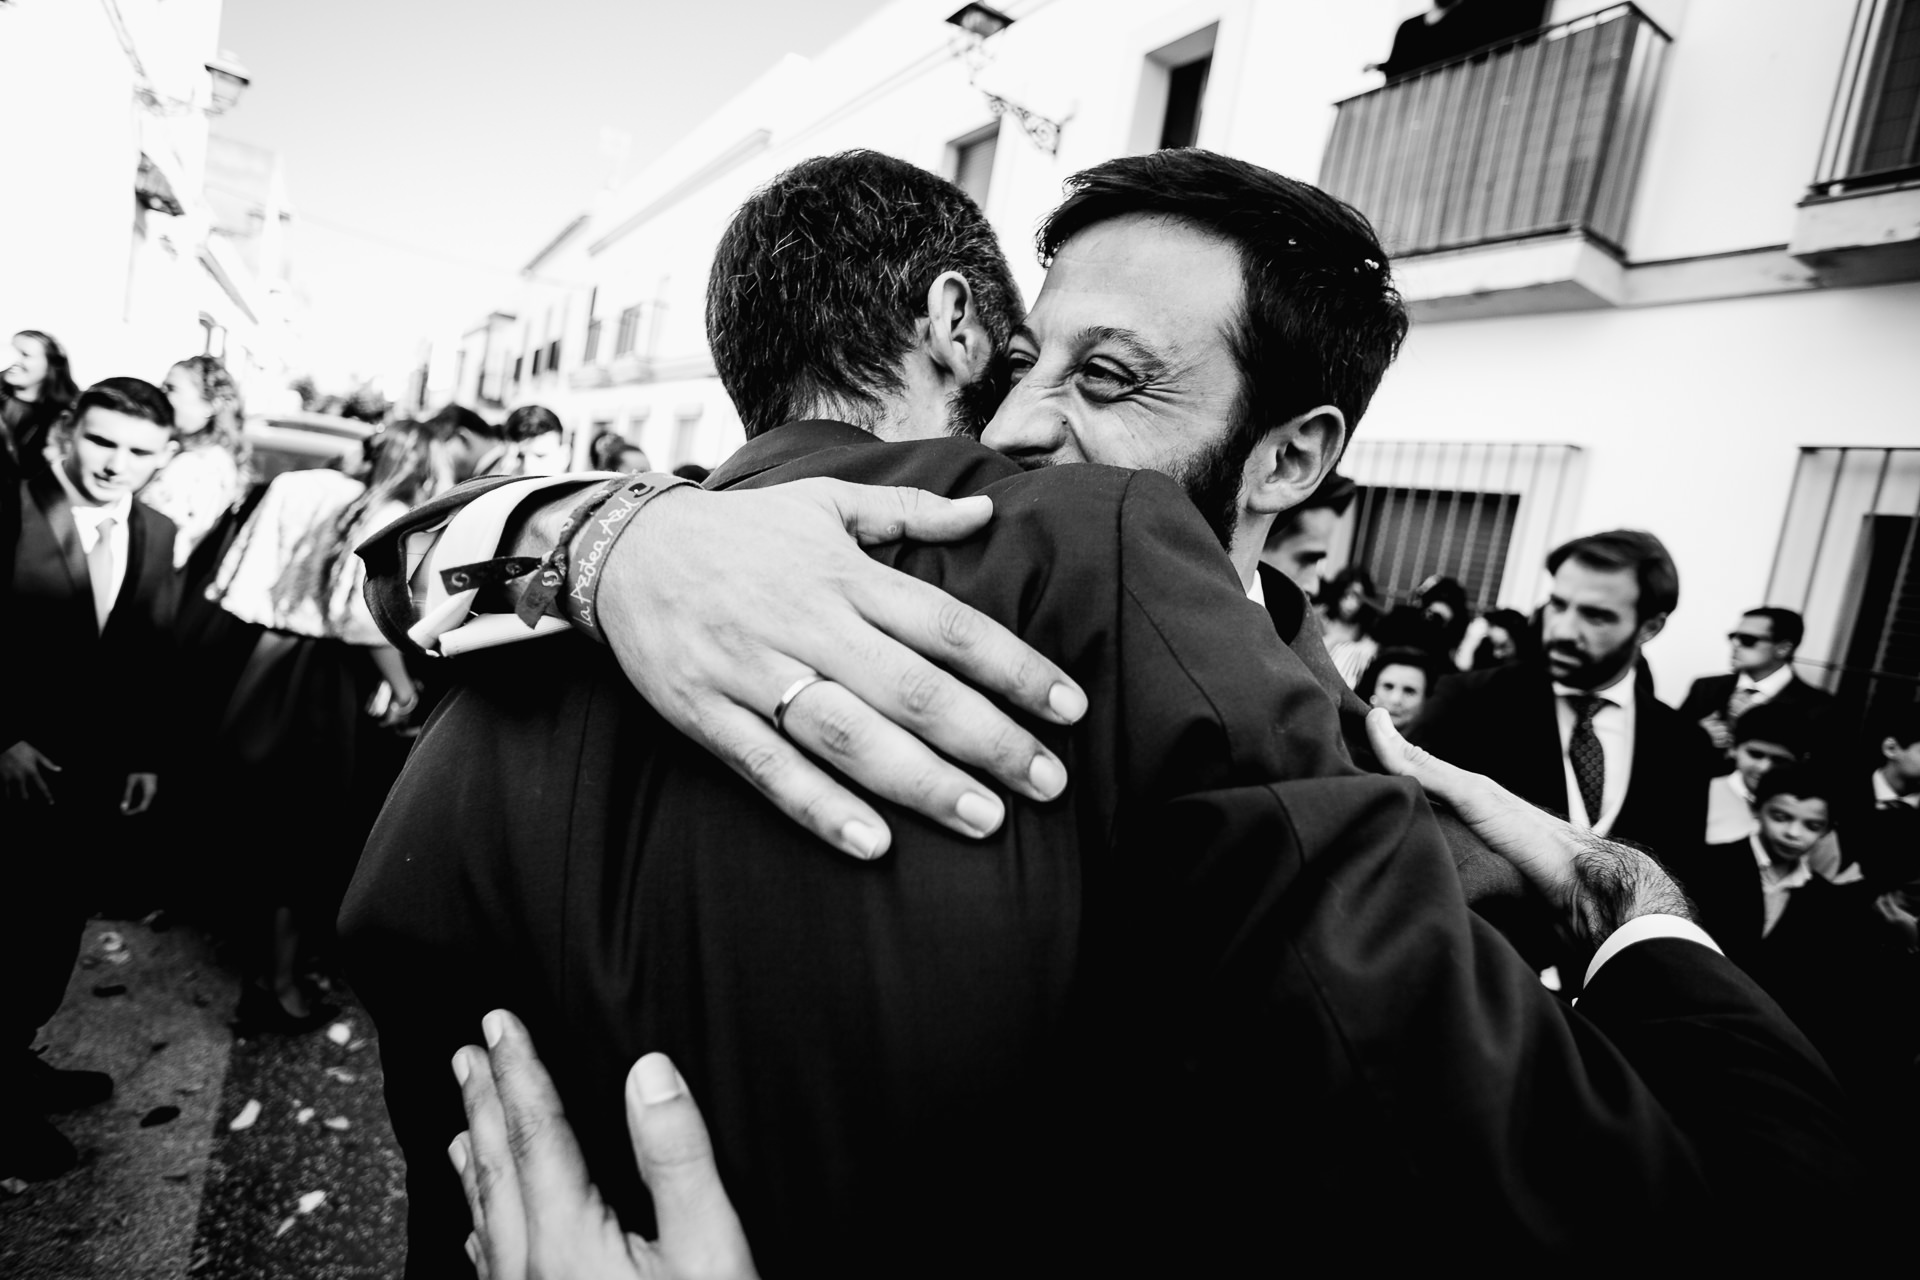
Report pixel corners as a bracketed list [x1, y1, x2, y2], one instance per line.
[1321, 4, 1670, 257]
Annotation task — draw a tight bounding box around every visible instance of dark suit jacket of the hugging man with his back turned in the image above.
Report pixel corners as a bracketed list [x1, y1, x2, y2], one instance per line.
[342, 424, 1851, 1274]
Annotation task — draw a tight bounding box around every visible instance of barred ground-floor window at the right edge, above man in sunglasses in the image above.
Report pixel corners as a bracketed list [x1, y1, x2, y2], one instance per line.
[1766, 447, 1920, 725]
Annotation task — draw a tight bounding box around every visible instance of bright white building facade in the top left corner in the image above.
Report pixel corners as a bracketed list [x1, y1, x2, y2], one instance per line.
[0, 0, 292, 401]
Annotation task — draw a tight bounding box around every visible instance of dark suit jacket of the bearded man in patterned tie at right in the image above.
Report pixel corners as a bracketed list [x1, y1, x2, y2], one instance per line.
[1407, 664, 1713, 858]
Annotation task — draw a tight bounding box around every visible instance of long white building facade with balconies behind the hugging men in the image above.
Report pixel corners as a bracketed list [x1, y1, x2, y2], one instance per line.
[424, 0, 1920, 721]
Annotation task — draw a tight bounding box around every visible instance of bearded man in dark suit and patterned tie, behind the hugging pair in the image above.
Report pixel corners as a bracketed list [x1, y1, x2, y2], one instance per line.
[1407, 530, 1709, 856]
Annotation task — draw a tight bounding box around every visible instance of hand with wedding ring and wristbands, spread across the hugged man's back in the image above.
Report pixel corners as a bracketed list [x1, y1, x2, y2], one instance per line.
[599, 480, 1087, 858]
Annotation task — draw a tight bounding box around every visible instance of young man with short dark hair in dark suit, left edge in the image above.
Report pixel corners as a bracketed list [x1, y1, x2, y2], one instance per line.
[0, 378, 177, 1178]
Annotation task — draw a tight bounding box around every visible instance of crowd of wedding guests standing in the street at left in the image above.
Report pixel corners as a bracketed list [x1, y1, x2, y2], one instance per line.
[0, 330, 660, 1178]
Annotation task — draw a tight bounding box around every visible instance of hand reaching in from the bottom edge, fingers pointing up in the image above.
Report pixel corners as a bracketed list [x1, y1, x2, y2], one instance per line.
[447, 1009, 758, 1280]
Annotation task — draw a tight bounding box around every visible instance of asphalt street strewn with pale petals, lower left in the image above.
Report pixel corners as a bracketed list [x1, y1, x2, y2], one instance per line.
[0, 919, 405, 1280]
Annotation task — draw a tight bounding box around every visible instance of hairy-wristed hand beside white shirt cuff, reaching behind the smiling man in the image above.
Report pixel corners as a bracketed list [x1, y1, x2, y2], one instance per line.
[1367, 708, 1693, 946]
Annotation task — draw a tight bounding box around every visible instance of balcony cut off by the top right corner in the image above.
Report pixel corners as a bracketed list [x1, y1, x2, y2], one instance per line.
[1788, 0, 1920, 284]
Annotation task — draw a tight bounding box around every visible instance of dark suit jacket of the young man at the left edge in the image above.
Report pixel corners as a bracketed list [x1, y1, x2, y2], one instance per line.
[0, 470, 179, 785]
